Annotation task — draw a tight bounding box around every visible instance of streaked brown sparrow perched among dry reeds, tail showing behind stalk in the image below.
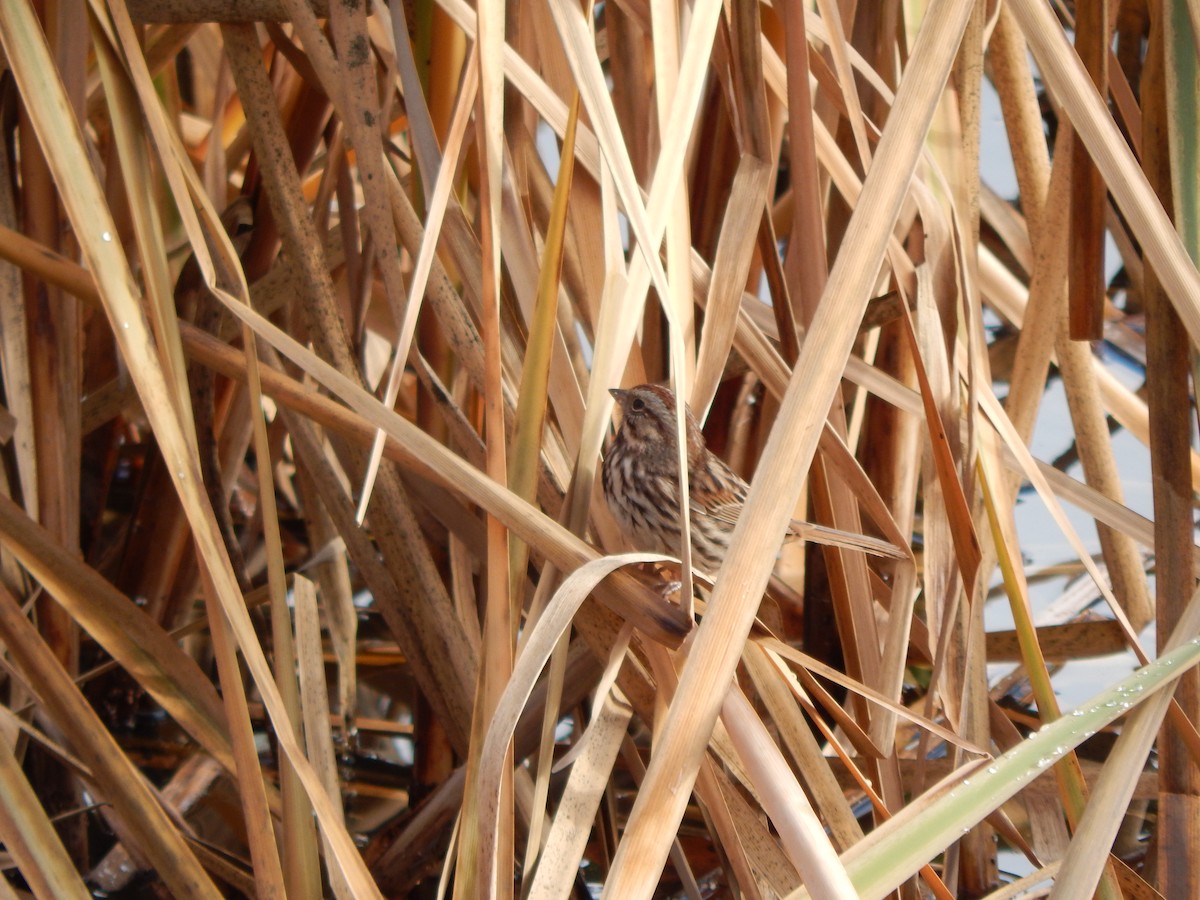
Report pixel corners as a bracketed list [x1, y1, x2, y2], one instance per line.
[601, 384, 904, 575]
